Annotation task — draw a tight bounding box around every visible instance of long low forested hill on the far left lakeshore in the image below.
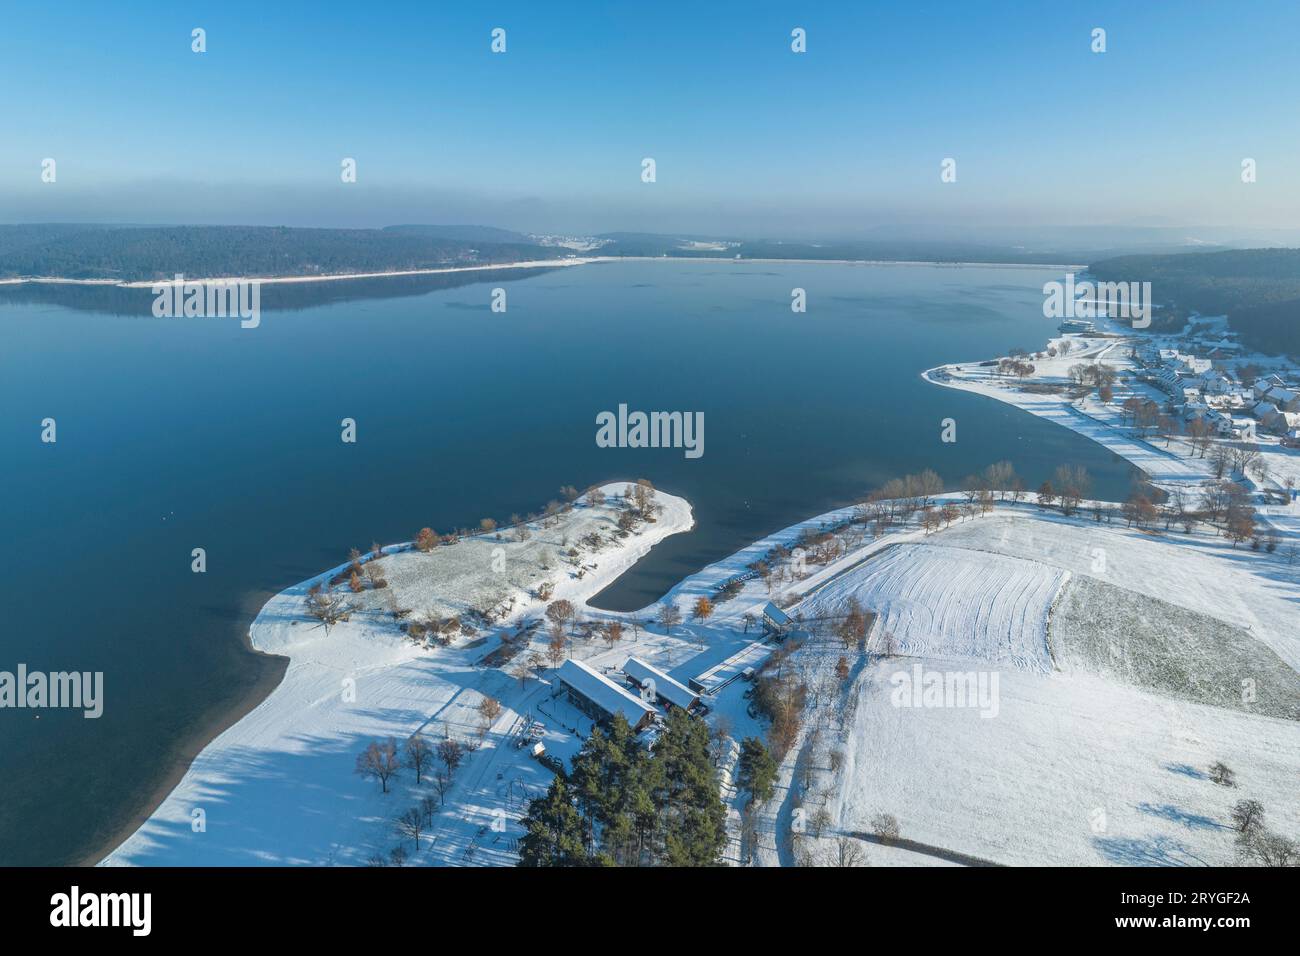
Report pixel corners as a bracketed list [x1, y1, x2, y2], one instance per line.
[0, 225, 562, 281]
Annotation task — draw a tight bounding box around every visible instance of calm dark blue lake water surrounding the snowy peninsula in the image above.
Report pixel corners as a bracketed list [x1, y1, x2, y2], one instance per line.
[0, 260, 1134, 864]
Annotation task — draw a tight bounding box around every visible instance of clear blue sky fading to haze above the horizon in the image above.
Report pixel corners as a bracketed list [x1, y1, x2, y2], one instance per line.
[0, 0, 1300, 235]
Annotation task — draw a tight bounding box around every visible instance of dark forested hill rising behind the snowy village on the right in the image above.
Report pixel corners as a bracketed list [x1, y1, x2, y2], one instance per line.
[1088, 248, 1300, 355]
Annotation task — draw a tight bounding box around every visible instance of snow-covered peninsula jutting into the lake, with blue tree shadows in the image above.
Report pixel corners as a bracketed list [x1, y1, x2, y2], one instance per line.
[103, 484, 693, 865]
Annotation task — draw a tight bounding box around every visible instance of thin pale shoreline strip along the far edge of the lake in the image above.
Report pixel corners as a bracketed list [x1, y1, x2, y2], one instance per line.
[0, 256, 1087, 289]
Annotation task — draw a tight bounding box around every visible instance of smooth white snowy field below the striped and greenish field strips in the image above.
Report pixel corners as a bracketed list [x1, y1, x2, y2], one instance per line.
[827, 666, 1300, 865]
